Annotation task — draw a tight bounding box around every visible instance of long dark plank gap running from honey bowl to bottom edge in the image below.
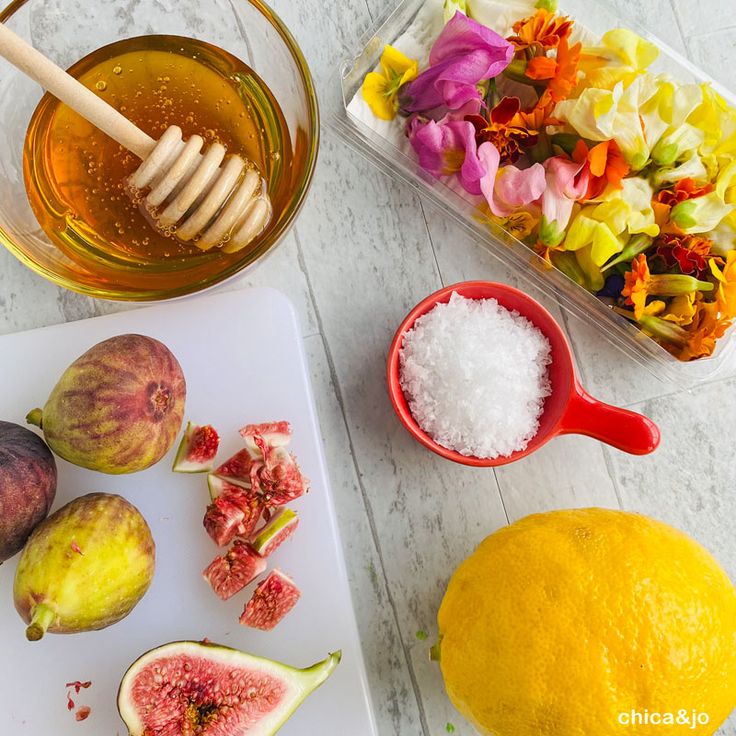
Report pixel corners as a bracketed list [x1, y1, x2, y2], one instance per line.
[294, 227, 430, 736]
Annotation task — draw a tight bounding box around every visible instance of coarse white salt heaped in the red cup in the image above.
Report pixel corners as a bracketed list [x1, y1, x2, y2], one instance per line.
[399, 292, 552, 458]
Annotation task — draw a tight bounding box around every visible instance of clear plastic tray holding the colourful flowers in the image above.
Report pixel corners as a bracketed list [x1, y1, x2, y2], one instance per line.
[329, 0, 736, 387]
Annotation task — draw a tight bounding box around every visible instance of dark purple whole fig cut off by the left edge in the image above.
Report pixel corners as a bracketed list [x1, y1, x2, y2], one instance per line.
[0, 422, 56, 563]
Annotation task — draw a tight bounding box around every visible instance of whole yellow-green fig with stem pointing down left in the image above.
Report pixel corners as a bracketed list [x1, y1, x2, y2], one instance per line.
[13, 493, 156, 641]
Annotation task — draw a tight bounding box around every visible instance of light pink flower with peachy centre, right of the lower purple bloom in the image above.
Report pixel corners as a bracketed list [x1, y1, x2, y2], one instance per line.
[478, 142, 546, 217]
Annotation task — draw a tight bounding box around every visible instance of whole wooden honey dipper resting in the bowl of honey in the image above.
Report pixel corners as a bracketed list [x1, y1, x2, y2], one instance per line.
[0, 23, 272, 253]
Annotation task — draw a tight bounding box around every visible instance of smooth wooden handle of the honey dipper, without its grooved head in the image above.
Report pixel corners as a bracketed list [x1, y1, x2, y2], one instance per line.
[0, 23, 156, 160]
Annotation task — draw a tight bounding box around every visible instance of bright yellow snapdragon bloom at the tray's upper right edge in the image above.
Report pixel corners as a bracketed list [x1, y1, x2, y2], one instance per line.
[580, 28, 659, 90]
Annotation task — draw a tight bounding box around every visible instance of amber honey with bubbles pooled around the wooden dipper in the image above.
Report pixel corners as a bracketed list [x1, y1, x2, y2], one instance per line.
[24, 36, 295, 288]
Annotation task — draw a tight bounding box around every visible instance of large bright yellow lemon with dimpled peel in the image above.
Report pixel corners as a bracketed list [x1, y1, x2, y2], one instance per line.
[437, 509, 736, 736]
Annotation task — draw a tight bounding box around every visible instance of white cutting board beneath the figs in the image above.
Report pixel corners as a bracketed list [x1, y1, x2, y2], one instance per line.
[0, 289, 376, 736]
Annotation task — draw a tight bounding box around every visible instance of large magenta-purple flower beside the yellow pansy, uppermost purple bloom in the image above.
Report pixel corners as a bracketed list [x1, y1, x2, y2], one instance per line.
[400, 13, 514, 112]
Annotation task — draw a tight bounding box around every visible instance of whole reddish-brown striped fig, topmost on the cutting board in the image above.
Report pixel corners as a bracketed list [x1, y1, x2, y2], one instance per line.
[27, 335, 186, 474]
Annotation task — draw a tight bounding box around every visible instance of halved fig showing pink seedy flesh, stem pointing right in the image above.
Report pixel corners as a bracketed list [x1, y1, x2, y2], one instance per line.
[118, 641, 341, 736]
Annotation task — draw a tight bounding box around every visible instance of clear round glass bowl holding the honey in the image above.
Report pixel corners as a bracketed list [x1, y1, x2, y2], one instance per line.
[0, 0, 319, 301]
